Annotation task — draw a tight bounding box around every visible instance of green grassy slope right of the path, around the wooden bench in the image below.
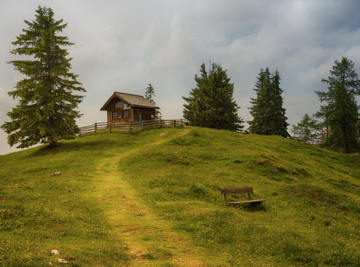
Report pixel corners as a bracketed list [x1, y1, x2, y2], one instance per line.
[119, 128, 360, 266]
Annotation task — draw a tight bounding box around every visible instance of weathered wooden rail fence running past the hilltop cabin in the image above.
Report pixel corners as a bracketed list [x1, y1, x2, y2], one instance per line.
[79, 119, 185, 135]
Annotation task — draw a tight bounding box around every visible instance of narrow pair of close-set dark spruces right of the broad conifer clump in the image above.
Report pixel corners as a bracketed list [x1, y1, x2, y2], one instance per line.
[248, 68, 290, 137]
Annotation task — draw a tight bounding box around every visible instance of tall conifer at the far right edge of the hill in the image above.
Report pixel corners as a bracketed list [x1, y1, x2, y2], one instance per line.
[315, 57, 360, 153]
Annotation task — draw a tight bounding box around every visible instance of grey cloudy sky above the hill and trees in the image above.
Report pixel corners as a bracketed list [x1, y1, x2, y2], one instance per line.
[0, 0, 360, 154]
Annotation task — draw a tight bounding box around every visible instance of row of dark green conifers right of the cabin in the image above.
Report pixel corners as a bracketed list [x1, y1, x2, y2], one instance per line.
[183, 57, 360, 153]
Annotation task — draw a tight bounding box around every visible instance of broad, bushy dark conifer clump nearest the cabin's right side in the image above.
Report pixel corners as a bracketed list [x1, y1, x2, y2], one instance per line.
[183, 63, 243, 131]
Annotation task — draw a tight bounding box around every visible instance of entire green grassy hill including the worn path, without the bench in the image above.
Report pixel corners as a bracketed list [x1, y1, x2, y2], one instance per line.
[0, 127, 360, 266]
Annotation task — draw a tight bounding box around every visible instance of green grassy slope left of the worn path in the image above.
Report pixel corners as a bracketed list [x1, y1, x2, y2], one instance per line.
[0, 134, 148, 266]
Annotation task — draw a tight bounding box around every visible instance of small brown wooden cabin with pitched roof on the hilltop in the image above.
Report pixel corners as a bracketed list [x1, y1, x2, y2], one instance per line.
[100, 92, 159, 123]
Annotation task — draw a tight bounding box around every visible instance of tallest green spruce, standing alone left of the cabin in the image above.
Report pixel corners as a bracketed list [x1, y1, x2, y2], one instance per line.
[1, 6, 86, 148]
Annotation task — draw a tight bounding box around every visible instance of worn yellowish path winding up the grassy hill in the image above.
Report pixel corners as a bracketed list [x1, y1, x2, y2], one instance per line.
[96, 130, 215, 266]
